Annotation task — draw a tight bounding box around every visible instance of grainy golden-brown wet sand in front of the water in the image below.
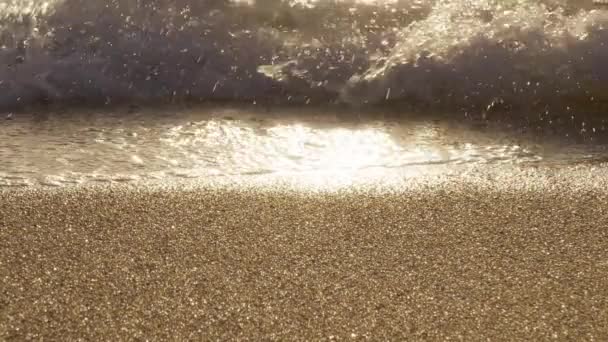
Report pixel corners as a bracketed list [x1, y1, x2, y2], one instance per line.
[0, 179, 608, 341]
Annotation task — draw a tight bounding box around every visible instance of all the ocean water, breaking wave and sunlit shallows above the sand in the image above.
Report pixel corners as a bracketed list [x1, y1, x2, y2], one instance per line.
[0, 0, 608, 187]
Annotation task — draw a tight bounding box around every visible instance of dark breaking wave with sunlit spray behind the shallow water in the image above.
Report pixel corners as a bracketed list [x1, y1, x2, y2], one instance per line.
[0, 0, 608, 116]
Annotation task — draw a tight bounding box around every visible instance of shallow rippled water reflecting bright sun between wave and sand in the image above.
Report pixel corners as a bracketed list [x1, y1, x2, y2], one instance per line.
[0, 108, 603, 187]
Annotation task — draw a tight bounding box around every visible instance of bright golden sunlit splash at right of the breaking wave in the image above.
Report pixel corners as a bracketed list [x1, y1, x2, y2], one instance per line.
[346, 0, 608, 108]
